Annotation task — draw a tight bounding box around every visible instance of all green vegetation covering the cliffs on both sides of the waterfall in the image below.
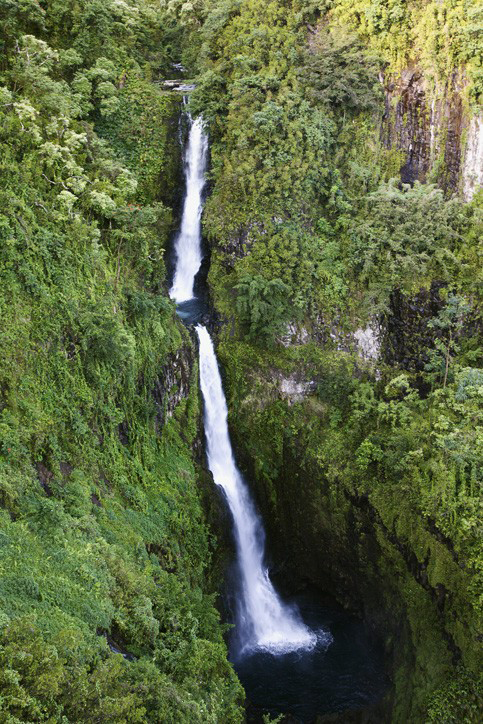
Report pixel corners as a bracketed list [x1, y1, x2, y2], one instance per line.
[0, 0, 483, 723]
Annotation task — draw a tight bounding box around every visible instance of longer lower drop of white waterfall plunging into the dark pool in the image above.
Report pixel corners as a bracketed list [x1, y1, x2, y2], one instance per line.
[196, 325, 317, 653]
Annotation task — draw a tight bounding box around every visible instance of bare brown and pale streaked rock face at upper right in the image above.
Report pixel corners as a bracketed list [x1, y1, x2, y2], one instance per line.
[381, 67, 483, 195]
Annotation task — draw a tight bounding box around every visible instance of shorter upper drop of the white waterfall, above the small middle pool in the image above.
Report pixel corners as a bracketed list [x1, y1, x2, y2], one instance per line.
[169, 106, 208, 303]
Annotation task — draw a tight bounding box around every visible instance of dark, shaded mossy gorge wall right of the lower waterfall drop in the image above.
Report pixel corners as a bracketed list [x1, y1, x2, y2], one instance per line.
[221, 344, 477, 724]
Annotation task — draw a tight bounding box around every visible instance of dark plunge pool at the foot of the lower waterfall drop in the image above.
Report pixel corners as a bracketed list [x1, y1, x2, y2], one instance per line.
[230, 590, 388, 724]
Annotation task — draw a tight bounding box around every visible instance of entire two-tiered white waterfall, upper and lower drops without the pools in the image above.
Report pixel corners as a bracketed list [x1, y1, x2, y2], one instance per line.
[170, 107, 317, 654]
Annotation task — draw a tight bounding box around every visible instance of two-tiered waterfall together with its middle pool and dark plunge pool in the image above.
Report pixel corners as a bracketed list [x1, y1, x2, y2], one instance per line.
[170, 99, 384, 722]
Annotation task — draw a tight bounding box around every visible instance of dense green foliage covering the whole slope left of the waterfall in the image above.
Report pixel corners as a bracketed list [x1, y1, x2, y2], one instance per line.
[0, 0, 241, 722]
